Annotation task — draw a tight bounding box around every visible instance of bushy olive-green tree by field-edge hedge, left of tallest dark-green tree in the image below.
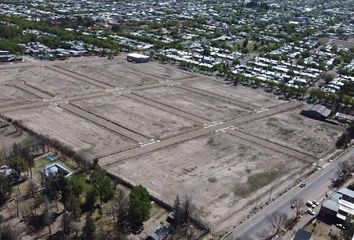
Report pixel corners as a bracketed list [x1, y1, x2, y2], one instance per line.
[91, 169, 115, 204]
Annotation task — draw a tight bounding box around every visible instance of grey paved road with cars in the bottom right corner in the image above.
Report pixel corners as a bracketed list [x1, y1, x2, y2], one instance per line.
[224, 149, 354, 240]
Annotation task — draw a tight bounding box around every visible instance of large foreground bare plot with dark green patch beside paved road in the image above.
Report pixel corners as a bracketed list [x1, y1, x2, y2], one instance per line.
[107, 133, 306, 227]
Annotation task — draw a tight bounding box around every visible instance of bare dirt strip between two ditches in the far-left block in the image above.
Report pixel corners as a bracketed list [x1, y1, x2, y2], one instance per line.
[0, 67, 102, 97]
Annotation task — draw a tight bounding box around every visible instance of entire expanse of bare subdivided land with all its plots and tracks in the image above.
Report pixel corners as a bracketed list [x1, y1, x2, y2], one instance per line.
[0, 56, 342, 232]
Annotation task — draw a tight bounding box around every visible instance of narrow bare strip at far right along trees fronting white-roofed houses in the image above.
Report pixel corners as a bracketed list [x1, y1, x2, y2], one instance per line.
[183, 78, 282, 108]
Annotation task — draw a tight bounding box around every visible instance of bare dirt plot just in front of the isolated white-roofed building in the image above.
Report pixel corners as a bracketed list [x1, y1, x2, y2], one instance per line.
[57, 60, 161, 88]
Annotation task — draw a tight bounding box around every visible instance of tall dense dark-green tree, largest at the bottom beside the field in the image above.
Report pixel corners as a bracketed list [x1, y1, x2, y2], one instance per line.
[129, 185, 151, 228]
